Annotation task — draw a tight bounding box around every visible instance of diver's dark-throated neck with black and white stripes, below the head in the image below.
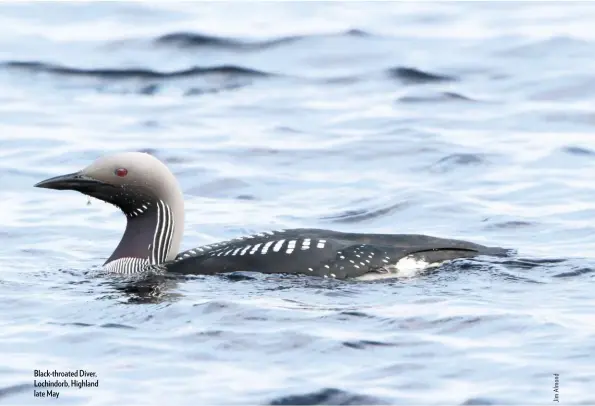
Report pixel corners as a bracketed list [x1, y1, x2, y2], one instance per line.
[104, 200, 184, 265]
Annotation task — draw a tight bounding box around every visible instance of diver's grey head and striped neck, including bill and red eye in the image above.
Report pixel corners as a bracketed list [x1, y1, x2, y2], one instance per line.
[35, 152, 184, 272]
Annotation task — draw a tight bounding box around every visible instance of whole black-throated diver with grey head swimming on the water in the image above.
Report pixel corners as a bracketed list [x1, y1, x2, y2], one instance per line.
[35, 152, 508, 279]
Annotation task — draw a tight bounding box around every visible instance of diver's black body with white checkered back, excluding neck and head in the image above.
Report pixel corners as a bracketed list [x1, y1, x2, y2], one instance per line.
[164, 229, 506, 279]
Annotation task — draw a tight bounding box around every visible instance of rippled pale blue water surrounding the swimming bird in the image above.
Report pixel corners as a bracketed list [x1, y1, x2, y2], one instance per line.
[0, 2, 595, 405]
